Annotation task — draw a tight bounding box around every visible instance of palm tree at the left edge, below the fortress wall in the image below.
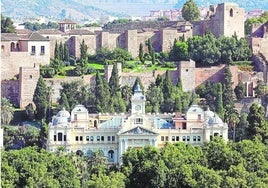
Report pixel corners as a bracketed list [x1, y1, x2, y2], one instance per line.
[1, 97, 14, 124]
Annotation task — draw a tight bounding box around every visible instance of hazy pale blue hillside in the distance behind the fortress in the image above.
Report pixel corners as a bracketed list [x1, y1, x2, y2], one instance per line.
[1, 0, 268, 20]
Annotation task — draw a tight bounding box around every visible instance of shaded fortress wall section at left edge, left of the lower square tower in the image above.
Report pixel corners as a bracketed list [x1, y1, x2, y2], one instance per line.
[1, 80, 19, 106]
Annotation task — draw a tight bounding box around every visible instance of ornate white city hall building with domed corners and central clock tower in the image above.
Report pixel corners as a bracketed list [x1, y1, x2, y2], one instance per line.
[47, 85, 228, 164]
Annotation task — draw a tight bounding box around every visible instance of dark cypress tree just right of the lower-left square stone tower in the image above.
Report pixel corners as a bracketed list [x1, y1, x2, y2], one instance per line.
[33, 76, 48, 120]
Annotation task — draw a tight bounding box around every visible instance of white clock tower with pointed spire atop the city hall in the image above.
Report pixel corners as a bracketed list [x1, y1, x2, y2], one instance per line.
[131, 83, 146, 114]
